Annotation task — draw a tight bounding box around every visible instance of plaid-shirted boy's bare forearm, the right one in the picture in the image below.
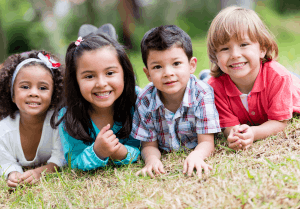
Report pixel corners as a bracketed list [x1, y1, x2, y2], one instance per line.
[194, 134, 215, 160]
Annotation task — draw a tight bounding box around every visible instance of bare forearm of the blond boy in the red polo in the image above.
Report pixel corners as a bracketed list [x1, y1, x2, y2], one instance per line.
[251, 120, 287, 141]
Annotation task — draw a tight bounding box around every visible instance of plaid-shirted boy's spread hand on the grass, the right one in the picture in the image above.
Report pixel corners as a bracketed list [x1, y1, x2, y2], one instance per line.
[183, 150, 212, 178]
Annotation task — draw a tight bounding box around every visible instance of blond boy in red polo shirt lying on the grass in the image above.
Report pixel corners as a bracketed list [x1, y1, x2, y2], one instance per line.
[207, 6, 300, 150]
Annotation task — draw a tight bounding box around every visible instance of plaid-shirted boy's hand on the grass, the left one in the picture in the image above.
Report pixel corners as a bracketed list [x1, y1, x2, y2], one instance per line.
[135, 156, 165, 178]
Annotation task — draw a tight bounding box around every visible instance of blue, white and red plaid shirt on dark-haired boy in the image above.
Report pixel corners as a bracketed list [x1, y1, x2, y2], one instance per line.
[131, 75, 221, 152]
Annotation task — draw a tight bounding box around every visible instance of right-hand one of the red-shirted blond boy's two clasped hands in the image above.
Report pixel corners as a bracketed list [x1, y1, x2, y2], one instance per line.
[235, 124, 254, 150]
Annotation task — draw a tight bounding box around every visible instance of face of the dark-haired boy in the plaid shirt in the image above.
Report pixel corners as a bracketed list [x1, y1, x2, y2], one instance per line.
[144, 46, 197, 101]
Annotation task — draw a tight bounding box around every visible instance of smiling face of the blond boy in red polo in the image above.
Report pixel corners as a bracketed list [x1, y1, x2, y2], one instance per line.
[216, 35, 266, 81]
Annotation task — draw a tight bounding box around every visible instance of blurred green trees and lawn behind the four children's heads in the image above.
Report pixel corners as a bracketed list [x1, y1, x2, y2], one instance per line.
[0, 0, 300, 87]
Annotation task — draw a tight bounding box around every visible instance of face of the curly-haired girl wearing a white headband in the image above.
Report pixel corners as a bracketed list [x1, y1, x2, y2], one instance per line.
[13, 66, 53, 116]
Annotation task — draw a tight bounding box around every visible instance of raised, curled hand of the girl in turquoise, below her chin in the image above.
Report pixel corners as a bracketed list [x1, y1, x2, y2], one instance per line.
[94, 124, 121, 159]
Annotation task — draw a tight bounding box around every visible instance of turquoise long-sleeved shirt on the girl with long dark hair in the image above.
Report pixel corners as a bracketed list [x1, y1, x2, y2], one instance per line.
[58, 86, 141, 171]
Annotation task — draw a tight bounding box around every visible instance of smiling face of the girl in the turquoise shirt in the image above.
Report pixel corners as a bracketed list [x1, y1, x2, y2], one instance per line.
[76, 47, 124, 111]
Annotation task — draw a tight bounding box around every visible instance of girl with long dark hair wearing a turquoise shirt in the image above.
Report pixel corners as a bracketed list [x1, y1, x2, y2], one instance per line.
[57, 33, 140, 171]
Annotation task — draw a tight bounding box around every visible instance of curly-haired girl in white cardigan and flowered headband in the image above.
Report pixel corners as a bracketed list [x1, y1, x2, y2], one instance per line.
[0, 51, 65, 187]
